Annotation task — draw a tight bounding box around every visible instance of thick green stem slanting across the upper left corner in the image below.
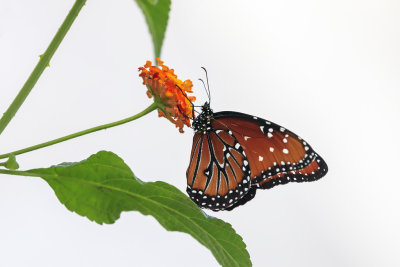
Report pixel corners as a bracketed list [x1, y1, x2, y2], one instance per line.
[0, 0, 86, 134]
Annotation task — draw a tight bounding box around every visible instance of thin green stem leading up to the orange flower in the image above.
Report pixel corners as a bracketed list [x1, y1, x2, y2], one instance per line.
[0, 102, 158, 159]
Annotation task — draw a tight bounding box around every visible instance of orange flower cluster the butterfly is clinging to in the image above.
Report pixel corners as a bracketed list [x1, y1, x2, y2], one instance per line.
[139, 58, 196, 133]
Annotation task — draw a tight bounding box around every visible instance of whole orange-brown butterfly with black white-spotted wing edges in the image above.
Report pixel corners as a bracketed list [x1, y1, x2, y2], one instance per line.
[186, 72, 328, 214]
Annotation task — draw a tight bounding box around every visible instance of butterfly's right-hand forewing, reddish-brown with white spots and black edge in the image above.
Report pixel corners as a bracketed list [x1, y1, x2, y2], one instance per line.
[212, 112, 328, 188]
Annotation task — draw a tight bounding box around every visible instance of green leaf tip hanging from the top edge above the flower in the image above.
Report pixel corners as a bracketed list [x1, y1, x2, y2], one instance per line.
[135, 0, 171, 57]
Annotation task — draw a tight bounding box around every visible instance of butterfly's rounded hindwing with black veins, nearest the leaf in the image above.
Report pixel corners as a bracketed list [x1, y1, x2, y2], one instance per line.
[186, 130, 251, 210]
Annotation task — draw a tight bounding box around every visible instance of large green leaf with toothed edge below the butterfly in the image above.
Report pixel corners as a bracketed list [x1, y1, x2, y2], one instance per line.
[22, 151, 251, 267]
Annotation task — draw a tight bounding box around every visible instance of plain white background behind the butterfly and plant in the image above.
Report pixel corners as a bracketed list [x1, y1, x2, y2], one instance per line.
[0, 0, 400, 267]
